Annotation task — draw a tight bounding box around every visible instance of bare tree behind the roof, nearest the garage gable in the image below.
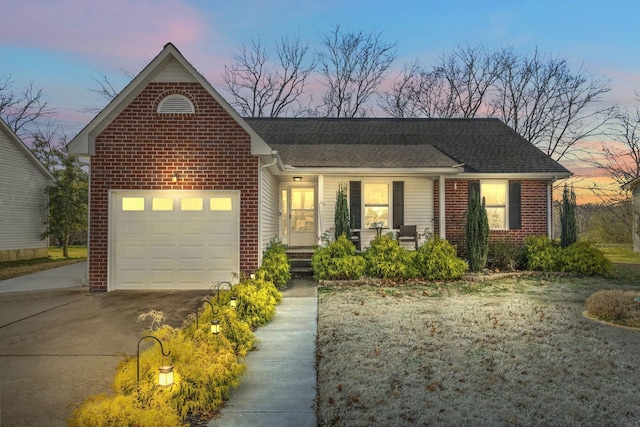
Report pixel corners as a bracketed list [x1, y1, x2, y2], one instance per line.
[222, 36, 315, 117]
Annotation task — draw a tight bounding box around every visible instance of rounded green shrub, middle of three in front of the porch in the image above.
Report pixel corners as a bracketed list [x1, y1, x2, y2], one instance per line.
[364, 235, 417, 279]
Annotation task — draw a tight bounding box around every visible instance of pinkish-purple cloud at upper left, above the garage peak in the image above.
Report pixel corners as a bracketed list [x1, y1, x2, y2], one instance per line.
[0, 0, 205, 65]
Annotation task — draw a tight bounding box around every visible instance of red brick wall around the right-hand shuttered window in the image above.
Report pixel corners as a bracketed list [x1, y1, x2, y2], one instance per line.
[434, 180, 548, 254]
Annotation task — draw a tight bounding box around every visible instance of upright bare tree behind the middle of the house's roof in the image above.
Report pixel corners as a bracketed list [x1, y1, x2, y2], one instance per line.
[318, 25, 396, 117]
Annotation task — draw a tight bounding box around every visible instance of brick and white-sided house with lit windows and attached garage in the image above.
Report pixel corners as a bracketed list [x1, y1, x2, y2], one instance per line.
[68, 44, 571, 291]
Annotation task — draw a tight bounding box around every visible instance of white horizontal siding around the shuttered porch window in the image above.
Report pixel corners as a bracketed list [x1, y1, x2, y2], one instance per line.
[320, 175, 434, 249]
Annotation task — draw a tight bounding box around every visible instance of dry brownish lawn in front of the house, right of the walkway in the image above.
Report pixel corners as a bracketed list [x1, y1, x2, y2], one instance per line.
[317, 278, 640, 426]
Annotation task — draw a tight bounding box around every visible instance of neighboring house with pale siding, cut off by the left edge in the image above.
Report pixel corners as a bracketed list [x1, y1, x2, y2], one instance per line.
[0, 119, 54, 262]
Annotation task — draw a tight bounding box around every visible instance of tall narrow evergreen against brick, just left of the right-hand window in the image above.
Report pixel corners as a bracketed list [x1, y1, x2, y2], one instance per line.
[467, 186, 489, 273]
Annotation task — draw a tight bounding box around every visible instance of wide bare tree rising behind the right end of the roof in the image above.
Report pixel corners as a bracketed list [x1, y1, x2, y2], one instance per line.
[493, 51, 613, 160]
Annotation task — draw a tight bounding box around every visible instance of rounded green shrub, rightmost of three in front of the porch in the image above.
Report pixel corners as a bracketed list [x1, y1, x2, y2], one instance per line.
[415, 236, 467, 280]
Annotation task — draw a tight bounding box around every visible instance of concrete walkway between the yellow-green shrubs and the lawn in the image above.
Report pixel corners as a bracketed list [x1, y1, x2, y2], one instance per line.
[209, 284, 318, 427]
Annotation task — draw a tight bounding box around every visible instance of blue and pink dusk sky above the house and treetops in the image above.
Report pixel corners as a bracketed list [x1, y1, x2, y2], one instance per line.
[0, 0, 640, 201]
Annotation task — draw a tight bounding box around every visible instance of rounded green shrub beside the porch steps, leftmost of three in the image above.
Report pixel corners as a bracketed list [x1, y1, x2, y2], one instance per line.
[311, 234, 365, 280]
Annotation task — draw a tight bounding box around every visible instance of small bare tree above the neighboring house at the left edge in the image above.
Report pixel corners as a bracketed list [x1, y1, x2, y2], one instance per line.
[0, 75, 54, 138]
